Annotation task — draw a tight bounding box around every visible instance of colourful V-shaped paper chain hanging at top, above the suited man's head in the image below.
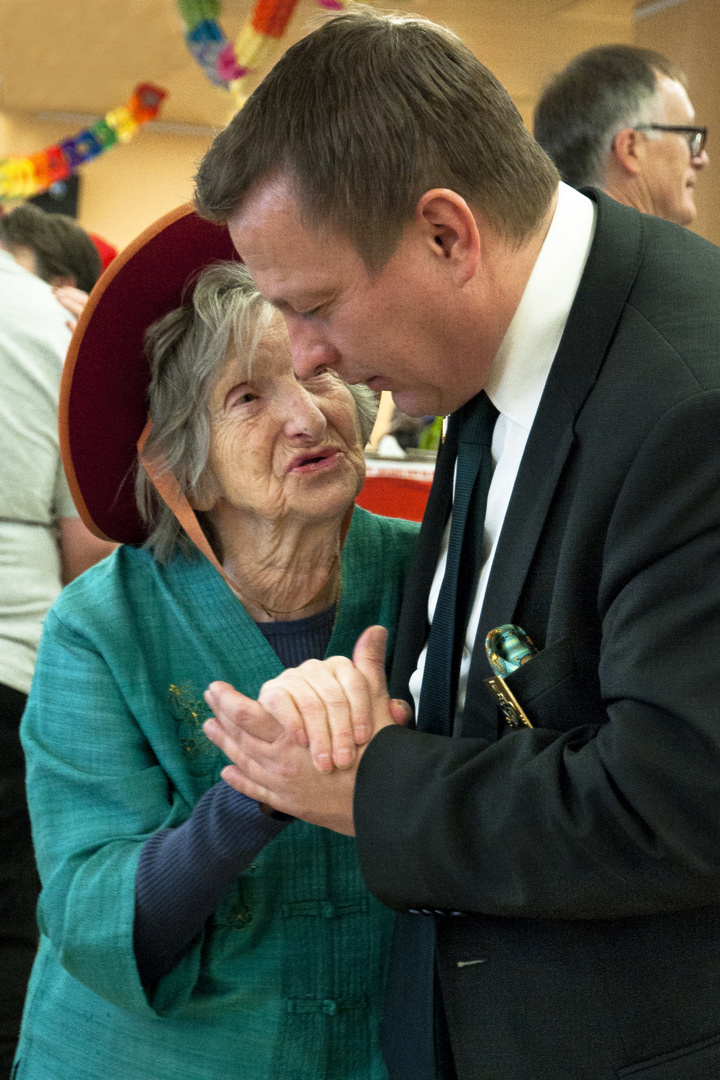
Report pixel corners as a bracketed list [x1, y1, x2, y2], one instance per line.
[177, 0, 344, 108]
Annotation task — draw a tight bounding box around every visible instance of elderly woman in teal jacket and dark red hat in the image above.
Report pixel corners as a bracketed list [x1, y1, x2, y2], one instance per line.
[14, 211, 415, 1080]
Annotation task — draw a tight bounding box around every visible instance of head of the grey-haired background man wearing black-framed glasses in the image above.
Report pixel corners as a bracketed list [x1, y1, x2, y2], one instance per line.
[534, 45, 708, 226]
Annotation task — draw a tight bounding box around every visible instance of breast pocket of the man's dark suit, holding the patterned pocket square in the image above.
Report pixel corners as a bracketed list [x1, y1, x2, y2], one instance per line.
[505, 637, 608, 731]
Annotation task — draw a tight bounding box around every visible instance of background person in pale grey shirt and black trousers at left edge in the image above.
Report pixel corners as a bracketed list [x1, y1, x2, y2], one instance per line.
[0, 205, 112, 1080]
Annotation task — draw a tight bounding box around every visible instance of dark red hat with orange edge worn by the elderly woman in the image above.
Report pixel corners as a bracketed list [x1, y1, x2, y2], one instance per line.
[59, 205, 237, 543]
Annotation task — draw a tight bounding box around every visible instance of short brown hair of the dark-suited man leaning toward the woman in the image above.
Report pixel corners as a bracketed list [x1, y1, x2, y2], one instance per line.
[195, 9, 558, 272]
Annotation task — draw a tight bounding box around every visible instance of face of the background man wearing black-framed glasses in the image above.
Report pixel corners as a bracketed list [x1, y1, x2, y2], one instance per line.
[640, 75, 708, 225]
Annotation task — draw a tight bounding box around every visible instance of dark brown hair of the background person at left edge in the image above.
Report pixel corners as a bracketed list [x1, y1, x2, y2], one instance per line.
[0, 203, 103, 293]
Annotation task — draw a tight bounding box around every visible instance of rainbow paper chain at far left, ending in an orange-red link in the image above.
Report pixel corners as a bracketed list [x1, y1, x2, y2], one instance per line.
[0, 82, 166, 200]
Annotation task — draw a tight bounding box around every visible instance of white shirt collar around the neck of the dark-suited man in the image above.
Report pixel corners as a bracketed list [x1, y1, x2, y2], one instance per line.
[485, 184, 596, 430]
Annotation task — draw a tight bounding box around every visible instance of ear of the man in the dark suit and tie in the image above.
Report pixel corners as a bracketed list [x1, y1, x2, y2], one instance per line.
[416, 188, 480, 285]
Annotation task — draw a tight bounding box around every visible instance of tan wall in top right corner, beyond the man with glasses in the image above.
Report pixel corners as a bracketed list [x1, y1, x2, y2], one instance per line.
[635, 0, 720, 244]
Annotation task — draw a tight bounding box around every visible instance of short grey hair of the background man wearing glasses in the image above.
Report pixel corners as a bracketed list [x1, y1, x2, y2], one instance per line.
[534, 45, 687, 188]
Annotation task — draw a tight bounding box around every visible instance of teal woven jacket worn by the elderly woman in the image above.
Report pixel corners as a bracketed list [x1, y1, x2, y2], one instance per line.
[15, 509, 417, 1080]
